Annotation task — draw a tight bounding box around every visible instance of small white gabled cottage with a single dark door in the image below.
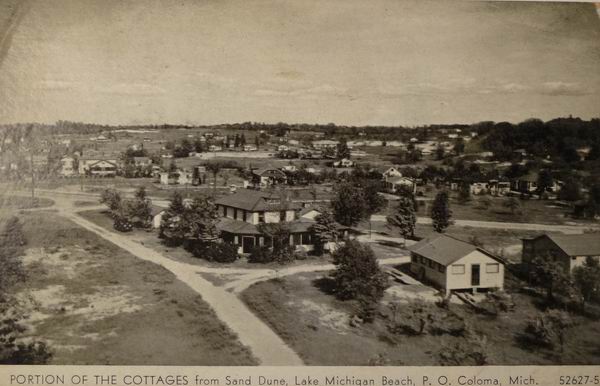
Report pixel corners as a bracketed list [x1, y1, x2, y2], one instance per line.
[409, 234, 505, 295]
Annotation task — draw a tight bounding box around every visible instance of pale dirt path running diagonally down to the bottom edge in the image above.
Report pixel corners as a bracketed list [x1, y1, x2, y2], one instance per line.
[60, 211, 304, 366]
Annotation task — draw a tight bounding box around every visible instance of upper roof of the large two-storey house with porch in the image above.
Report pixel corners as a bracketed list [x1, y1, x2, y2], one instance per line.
[215, 189, 302, 212]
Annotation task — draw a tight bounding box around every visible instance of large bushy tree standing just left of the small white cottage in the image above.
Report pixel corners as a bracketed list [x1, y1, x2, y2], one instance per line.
[331, 240, 389, 320]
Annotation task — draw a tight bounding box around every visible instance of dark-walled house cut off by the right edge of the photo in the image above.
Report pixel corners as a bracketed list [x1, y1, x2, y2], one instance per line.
[522, 233, 600, 272]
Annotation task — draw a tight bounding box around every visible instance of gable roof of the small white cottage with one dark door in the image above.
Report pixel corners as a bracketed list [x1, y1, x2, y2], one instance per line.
[408, 234, 504, 267]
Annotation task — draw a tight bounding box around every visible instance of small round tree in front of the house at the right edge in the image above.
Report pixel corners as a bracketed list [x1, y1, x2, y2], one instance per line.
[529, 256, 569, 302]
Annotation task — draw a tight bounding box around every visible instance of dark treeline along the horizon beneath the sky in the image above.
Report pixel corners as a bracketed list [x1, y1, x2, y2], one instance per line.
[0, 117, 600, 153]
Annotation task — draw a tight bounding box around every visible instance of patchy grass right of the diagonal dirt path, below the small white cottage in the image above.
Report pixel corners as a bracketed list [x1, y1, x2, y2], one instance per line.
[242, 273, 600, 366]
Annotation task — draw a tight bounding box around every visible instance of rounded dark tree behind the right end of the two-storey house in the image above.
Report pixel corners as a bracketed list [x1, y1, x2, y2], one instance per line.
[331, 182, 369, 226]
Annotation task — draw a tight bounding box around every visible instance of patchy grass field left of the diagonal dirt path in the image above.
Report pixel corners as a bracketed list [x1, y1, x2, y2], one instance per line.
[10, 212, 256, 365]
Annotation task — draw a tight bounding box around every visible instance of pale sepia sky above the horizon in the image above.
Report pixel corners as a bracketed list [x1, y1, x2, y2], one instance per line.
[0, 0, 600, 125]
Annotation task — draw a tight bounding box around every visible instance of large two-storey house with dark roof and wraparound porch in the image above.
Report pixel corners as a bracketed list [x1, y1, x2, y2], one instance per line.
[215, 189, 347, 254]
